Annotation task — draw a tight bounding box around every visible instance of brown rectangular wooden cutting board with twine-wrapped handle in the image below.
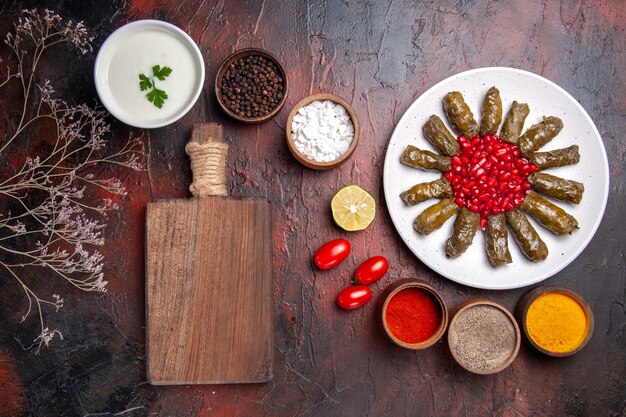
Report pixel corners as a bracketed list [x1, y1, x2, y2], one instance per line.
[146, 124, 273, 385]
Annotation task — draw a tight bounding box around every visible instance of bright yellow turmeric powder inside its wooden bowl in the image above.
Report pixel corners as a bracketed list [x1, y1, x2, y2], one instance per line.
[526, 292, 589, 353]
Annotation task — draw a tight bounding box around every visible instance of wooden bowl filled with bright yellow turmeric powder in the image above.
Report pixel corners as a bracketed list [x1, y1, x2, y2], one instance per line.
[515, 286, 594, 357]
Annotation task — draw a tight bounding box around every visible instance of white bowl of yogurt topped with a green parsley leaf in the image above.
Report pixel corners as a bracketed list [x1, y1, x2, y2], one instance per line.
[94, 20, 204, 129]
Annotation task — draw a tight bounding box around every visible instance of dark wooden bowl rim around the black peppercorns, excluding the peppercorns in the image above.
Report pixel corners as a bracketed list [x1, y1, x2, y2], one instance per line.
[215, 48, 289, 124]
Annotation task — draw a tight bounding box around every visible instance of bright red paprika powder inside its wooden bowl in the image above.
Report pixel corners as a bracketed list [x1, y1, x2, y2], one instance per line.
[385, 288, 442, 343]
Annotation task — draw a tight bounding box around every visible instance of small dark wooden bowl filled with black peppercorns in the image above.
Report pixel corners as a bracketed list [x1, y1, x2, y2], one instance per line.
[215, 48, 287, 124]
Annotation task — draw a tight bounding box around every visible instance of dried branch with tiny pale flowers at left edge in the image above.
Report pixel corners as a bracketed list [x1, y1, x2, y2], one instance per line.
[0, 10, 145, 352]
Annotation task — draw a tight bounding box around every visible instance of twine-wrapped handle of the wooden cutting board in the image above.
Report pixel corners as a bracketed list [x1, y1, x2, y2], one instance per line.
[185, 123, 228, 197]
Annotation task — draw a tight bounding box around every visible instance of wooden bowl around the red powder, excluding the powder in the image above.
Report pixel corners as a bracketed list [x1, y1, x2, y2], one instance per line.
[380, 278, 448, 350]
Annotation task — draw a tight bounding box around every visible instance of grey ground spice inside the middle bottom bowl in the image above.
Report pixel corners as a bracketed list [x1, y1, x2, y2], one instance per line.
[449, 305, 516, 372]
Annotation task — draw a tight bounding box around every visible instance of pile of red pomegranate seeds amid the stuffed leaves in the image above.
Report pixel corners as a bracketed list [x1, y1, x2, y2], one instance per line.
[443, 135, 539, 229]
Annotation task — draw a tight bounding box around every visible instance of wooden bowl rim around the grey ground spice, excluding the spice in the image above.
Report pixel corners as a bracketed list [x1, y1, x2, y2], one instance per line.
[448, 298, 521, 375]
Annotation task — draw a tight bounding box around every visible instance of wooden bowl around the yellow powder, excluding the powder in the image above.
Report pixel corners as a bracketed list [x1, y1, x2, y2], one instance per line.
[515, 285, 594, 358]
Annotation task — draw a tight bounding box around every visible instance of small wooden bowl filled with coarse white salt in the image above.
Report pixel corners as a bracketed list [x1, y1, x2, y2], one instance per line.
[285, 93, 359, 170]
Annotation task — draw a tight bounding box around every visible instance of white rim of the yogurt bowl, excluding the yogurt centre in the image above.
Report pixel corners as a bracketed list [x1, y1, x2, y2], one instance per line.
[93, 19, 205, 129]
